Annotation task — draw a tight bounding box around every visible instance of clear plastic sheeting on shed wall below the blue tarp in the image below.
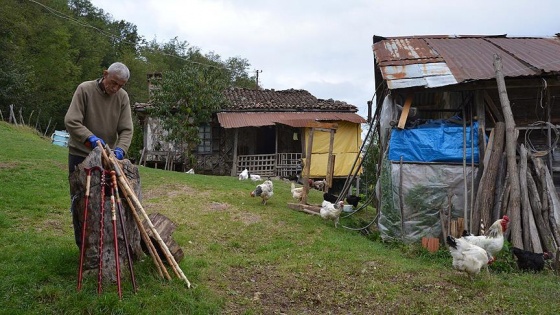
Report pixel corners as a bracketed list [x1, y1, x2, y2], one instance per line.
[378, 159, 478, 244]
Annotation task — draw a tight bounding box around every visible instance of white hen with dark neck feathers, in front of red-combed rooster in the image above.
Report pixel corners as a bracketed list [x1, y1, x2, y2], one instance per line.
[446, 235, 494, 280]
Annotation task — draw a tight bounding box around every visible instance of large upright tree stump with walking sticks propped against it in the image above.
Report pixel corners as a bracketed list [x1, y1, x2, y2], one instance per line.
[69, 147, 143, 281]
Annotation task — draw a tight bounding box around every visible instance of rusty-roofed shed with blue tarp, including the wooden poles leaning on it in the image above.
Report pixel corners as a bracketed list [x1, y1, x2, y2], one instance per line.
[370, 35, 560, 251]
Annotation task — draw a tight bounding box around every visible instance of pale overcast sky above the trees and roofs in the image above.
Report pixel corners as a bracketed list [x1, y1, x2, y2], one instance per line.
[90, 0, 560, 117]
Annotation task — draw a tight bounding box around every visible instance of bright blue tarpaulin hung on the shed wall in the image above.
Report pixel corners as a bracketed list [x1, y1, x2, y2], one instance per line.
[389, 120, 480, 163]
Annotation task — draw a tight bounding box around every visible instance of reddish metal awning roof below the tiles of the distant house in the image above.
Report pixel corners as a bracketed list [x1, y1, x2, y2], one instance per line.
[217, 112, 366, 128]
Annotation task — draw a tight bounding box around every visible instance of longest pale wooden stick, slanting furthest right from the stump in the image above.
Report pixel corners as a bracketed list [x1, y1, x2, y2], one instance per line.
[103, 144, 191, 288]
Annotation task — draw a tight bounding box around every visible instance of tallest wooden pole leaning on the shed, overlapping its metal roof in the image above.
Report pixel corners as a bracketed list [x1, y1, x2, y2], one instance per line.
[494, 54, 524, 248]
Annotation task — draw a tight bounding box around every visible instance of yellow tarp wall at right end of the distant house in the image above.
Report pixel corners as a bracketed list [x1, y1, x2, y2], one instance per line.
[304, 121, 362, 178]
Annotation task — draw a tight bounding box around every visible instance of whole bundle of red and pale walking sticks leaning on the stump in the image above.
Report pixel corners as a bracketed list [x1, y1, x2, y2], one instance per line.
[77, 141, 191, 299]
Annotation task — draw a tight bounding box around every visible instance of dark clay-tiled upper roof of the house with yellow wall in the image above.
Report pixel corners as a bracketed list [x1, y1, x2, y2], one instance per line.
[222, 88, 358, 112]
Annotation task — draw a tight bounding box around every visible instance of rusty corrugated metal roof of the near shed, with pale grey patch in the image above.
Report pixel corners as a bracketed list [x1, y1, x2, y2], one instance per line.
[373, 35, 560, 89]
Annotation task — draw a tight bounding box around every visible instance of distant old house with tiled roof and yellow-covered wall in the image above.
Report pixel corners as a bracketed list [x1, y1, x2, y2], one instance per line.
[135, 88, 366, 190]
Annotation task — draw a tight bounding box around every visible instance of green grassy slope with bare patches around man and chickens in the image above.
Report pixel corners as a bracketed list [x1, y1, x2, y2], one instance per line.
[0, 122, 560, 314]
